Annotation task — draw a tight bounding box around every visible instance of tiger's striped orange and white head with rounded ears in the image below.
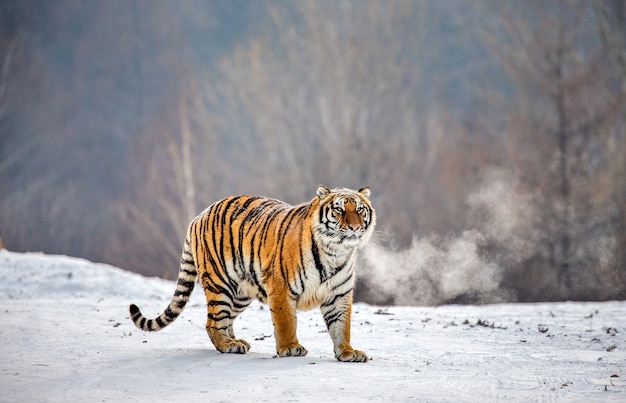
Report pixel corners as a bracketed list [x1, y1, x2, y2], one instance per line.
[315, 185, 376, 249]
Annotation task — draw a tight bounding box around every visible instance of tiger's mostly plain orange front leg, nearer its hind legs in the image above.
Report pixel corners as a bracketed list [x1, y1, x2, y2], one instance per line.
[268, 291, 308, 357]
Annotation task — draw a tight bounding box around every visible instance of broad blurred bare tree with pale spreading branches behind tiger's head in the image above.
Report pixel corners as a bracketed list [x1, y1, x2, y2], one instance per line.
[196, 1, 434, 245]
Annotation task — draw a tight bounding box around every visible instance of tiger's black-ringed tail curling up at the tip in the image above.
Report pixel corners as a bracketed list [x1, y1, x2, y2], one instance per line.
[129, 235, 198, 332]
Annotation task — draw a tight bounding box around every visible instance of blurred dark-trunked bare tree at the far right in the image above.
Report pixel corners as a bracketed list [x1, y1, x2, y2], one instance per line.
[488, 1, 621, 298]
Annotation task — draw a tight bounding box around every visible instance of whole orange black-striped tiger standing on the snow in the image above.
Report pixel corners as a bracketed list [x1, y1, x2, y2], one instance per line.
[129, 185, 376, 362]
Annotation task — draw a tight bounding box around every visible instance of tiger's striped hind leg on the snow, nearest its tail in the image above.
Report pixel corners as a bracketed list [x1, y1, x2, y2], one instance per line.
[206, 291, 251, 354]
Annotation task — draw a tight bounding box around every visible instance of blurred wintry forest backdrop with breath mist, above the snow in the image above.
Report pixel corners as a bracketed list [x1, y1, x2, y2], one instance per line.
[0, 0, 626, 304]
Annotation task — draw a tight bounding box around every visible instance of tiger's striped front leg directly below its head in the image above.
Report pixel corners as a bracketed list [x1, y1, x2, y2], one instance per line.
[320, 291, 369, 362]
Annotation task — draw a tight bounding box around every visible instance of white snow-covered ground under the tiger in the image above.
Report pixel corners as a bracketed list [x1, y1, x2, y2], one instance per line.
[0, 251, 626, 402]
